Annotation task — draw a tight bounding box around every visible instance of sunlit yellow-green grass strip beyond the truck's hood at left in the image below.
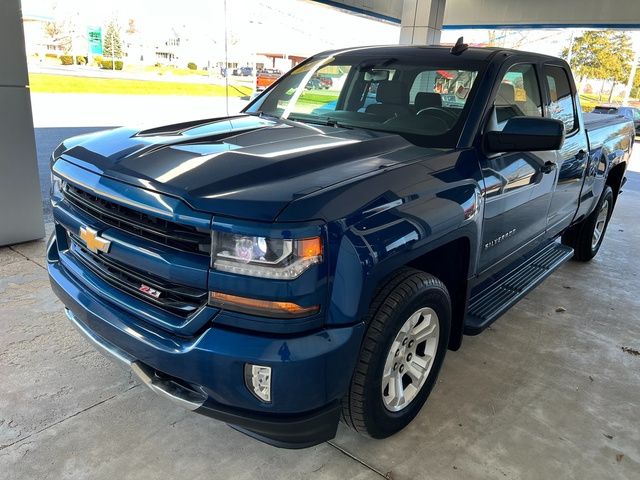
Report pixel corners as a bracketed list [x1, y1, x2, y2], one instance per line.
[29, 73, 251, 97]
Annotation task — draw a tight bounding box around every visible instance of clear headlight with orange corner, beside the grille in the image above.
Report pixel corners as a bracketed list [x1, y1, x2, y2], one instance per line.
[211, 232, 322, 280]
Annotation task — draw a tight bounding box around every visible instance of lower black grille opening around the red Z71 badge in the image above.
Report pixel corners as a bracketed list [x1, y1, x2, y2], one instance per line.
[69, 233, 207, 317]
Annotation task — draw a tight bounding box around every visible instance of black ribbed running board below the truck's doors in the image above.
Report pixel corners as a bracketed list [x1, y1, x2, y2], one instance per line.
[464, 242, 573, 335]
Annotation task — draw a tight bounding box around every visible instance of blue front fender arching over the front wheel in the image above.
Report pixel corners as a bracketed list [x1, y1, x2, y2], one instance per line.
[327, 181, 482, 324]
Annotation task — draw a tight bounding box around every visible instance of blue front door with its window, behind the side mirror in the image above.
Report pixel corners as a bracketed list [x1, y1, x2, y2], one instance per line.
[479, 62, 556, 272]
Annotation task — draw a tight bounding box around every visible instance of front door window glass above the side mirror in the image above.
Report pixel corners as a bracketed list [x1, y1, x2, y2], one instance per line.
[494, 63, 542, 125]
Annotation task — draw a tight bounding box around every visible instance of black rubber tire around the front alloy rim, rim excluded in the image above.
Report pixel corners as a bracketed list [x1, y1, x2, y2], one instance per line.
[342, 268, 451, 438]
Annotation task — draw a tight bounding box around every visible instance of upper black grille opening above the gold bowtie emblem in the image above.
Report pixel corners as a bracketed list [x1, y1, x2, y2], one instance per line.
[64, 183, 211, 255]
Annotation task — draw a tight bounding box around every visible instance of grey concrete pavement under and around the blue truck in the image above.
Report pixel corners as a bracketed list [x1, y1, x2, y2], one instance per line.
[0, 148, 640, 480]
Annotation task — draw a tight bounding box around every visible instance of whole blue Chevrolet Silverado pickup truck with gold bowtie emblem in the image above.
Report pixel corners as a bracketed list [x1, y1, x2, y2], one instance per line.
[47, 43, 634, 448]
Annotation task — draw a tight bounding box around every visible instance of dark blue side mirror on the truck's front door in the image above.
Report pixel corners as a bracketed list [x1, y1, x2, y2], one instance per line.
[484, 117, 564, 152]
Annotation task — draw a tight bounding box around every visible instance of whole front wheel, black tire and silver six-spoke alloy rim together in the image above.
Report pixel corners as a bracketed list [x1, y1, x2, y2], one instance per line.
[343, 268, 451, 438]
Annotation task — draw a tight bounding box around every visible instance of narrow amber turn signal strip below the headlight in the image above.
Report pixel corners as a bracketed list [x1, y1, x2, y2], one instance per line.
[209, 292, 320, 318]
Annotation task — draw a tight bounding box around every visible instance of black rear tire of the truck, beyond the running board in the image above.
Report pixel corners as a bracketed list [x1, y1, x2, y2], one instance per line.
[562, 185, 613, 262]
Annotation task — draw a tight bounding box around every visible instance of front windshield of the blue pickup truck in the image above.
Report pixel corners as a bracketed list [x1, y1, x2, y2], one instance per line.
[246, 54, 479, 147]
